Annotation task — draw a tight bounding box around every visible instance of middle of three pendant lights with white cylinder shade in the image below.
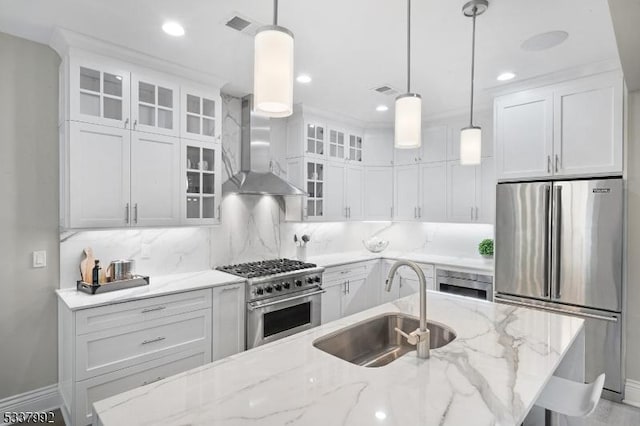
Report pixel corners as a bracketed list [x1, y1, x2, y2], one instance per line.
[394, 0, 422, 149]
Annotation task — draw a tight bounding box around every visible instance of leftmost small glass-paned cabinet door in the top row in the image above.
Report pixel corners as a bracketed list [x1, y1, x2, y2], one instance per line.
[70, 58, 130, 129]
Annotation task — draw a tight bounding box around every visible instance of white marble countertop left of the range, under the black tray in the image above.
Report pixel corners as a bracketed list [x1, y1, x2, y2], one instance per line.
[56, 270, 245, 311]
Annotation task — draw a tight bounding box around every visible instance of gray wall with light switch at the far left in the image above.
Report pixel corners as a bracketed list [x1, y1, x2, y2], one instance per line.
[0, 33, 60, 399]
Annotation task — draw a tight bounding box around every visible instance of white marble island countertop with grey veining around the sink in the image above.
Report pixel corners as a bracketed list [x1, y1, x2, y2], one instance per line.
[94, 292, 584, 426]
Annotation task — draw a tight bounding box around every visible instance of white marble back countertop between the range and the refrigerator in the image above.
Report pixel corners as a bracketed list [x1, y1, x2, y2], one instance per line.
[307, 250, 493, 274]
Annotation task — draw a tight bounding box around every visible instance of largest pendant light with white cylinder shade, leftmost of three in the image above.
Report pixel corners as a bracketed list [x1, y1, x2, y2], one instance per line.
[253, 0, 293, 117]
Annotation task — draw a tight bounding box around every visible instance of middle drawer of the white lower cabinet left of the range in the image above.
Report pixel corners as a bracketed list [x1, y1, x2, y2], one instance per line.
[76, 309, 211, 380]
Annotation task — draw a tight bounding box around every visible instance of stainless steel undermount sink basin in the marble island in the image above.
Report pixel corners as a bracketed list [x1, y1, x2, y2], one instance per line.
[313, 313, 456, 367]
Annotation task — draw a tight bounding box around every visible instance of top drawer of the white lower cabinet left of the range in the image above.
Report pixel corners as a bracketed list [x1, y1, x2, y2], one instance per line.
[76, 289, 211, 335]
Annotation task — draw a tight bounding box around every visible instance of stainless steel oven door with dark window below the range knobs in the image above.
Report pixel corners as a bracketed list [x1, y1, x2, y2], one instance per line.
[247, 287, 324, 349]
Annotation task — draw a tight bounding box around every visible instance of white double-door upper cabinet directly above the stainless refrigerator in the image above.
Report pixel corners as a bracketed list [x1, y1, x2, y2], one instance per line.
[495, 72, 624, 180]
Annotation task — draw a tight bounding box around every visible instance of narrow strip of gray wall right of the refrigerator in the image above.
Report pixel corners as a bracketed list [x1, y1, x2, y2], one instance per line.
[627, 91, 640, 381]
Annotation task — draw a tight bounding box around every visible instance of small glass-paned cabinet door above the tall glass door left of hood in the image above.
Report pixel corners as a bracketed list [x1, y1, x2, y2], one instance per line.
[180, 86, 222, 142]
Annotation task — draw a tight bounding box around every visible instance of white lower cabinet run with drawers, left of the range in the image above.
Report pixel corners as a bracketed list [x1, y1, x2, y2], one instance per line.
[58, 282, 245, 426]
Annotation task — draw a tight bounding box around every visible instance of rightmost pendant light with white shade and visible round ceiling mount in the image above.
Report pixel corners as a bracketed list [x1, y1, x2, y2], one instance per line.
[460, 0, 489, 165]
